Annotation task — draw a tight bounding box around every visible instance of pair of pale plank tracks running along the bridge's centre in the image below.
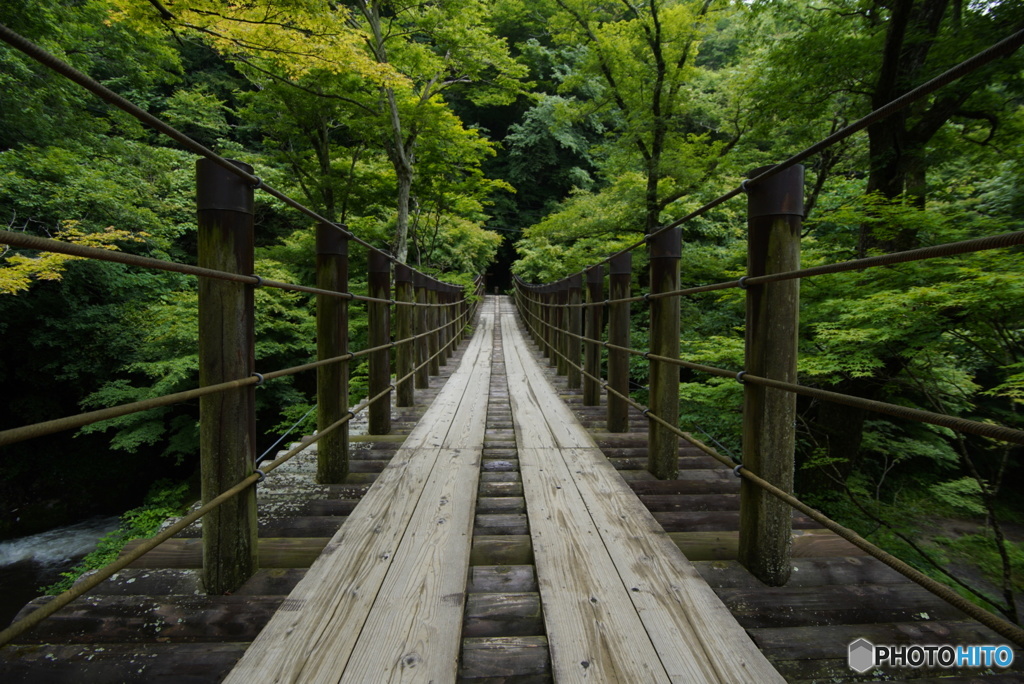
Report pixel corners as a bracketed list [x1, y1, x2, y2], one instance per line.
[226, 298, 781, 683]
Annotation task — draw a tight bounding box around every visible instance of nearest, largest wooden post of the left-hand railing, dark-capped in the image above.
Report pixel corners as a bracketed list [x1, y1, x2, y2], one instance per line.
[196, 159, 259, 594]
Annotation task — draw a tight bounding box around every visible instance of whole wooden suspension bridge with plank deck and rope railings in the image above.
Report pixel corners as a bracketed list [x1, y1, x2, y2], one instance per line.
[0, 21, 1024, 683]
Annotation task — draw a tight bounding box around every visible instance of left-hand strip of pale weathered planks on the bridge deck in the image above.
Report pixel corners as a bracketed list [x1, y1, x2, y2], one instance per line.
[224, 301, 494, 684]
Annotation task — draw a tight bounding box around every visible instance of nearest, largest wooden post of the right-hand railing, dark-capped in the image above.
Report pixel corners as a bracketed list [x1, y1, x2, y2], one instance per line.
[739, 165, 804, 587]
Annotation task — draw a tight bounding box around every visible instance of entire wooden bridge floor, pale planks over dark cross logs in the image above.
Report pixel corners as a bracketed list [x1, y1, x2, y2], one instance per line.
[0, 297, 1024, 684]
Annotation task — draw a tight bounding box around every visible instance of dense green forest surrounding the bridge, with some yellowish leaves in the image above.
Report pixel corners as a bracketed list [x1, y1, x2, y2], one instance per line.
[0, 0, 1024, 619]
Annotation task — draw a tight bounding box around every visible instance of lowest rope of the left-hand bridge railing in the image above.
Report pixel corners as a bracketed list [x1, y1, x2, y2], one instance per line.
[0, 290, 470, 646]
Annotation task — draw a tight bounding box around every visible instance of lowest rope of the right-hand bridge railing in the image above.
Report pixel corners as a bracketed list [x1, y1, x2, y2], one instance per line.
[515, 289, 1024, 648]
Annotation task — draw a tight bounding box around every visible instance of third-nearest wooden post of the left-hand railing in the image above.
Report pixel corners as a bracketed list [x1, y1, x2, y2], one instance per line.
[367, 250, 391, 434]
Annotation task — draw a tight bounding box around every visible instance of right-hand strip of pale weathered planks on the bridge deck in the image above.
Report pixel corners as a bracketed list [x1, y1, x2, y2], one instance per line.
[501, 307, 781, 682]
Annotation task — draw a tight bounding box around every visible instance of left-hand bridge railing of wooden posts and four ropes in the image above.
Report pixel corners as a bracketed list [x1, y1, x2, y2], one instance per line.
[0, 25, 483, 646]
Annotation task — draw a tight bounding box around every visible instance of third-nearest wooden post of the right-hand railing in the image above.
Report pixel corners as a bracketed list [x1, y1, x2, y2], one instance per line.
[608, 252, 633, 432]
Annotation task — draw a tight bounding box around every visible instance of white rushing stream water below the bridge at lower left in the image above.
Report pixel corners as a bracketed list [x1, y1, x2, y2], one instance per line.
[0, 516, 119, 628]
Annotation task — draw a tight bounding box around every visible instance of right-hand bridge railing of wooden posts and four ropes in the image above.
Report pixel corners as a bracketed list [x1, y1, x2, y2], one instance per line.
[515, 26, 1024, 646]
